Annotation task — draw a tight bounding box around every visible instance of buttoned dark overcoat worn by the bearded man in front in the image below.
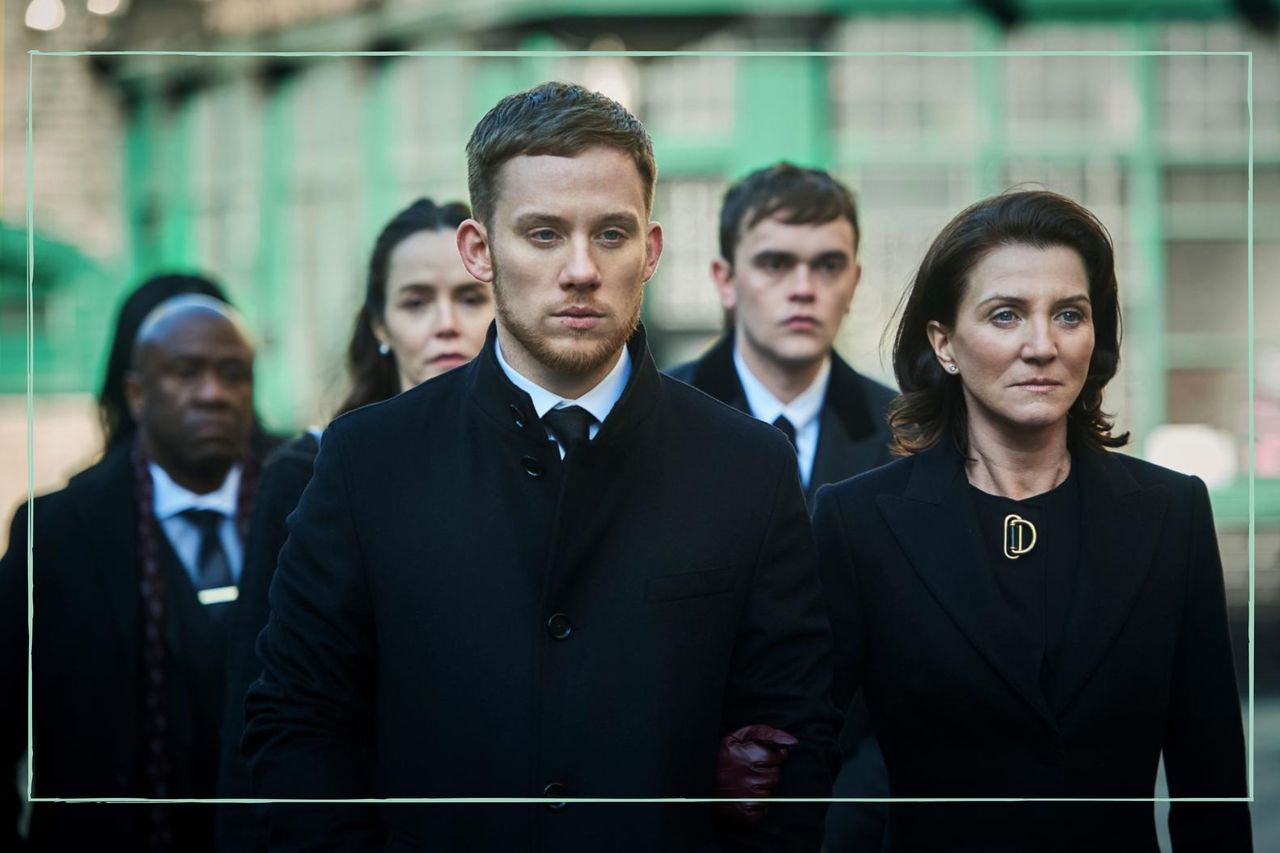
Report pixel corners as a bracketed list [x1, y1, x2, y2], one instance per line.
[244, 328, 838, 852]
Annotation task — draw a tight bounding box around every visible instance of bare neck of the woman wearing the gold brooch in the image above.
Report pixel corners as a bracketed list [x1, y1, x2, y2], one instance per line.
[965, 419, 1071, 501]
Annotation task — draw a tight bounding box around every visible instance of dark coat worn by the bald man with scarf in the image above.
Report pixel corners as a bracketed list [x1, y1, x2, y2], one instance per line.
[0, 441, 276, 850]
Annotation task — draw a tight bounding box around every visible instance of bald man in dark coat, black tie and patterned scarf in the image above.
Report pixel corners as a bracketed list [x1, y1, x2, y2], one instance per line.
[0, 296, 272, 852]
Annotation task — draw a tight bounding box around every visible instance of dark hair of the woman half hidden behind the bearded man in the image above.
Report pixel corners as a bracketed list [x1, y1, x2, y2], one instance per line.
[334, 199, 471, 418]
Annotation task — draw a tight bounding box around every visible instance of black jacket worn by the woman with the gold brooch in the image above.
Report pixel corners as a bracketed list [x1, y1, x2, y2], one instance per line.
[814, 439, 1249, 853]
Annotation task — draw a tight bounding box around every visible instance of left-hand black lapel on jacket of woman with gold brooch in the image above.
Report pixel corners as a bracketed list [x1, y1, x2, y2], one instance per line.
[877, 444, 1053, 722]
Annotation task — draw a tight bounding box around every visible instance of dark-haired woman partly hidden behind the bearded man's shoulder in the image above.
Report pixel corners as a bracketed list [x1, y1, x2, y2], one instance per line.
[218, 199, 483, 853]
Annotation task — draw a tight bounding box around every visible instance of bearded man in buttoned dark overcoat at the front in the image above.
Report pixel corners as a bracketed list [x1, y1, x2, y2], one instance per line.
[244, 83, 838, 853]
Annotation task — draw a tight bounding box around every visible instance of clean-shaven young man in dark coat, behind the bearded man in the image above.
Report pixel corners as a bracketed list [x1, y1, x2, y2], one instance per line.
[669, 163, 895, 853]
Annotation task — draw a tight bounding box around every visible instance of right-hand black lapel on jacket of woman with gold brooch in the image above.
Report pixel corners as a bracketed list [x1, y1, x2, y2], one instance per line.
[1053, 450, 1169, 711]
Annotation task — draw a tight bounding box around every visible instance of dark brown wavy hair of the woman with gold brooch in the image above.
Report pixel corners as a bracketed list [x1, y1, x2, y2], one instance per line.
[888, 190, 1129, 456]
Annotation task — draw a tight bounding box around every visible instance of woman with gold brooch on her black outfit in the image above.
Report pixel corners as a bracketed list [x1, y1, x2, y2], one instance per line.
[814, 192, 1251, 853]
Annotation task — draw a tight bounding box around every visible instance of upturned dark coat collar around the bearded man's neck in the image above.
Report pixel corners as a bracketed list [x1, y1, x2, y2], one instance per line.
[462, 321, 662, 456]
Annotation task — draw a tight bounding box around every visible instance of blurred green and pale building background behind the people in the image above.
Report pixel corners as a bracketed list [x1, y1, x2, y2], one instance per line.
[0, 0, 1280, 848]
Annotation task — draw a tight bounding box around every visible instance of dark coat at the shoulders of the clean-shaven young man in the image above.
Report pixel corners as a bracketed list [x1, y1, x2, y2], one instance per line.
[667, 334, 896, 505]
